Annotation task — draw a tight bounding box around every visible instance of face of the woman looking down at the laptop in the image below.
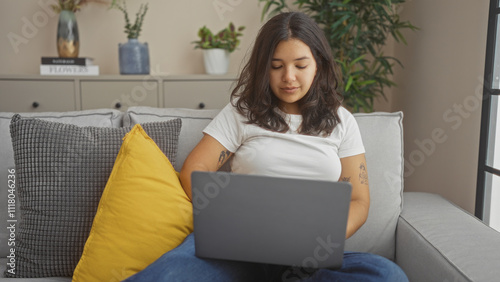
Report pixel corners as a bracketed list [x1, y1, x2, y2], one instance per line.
[269, 38, 316, 114]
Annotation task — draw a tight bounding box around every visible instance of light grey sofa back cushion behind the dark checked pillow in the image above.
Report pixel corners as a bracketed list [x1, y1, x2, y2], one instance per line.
[0, 110, 122, 257]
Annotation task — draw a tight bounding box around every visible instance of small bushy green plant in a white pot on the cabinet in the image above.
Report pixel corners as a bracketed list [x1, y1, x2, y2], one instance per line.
[192, 22, 245, 74]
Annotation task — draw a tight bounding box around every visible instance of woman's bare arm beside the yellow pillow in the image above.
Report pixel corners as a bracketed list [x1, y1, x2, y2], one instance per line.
[180, 134, 233, 199]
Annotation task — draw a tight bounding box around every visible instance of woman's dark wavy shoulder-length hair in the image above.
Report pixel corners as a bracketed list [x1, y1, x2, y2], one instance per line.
[231, 12, 343, 136]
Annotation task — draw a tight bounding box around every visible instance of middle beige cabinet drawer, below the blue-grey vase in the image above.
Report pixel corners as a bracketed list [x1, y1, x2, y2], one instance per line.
[80, 80, 159, 111]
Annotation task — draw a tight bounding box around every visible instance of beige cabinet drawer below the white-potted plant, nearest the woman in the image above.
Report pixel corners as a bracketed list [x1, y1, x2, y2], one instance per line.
[163, 80, 234, 109]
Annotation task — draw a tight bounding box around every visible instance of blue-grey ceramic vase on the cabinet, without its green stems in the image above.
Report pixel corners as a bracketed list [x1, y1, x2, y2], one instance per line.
[118, 39, 149, 74]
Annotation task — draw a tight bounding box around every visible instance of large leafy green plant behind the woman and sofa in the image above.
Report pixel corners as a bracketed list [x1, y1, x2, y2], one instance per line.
[259, 0, 417, 112]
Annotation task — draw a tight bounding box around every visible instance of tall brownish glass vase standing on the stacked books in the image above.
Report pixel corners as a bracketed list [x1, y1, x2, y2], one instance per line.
[57, 10, 80, 58]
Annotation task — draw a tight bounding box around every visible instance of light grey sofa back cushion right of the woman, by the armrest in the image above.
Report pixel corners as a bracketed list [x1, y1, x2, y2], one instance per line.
[346, 112, 404, 259]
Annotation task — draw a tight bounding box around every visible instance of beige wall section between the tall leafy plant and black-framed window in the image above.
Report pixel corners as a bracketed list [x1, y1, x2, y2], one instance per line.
[393, 0, 489, 212]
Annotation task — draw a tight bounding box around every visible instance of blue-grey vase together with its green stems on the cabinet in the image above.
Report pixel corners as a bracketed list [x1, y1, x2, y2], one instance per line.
[111, 0, 149, 74]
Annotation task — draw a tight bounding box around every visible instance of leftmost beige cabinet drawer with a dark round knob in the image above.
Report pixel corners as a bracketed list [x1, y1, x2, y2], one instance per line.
[0, 80, 76, 112]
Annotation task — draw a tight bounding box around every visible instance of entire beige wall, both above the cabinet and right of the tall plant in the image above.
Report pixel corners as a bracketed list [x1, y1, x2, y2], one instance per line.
[0, 0, 488, 211]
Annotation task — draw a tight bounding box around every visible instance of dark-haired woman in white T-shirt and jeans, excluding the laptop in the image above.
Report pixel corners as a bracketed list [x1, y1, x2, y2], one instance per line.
[127, 13, 407, 281]
